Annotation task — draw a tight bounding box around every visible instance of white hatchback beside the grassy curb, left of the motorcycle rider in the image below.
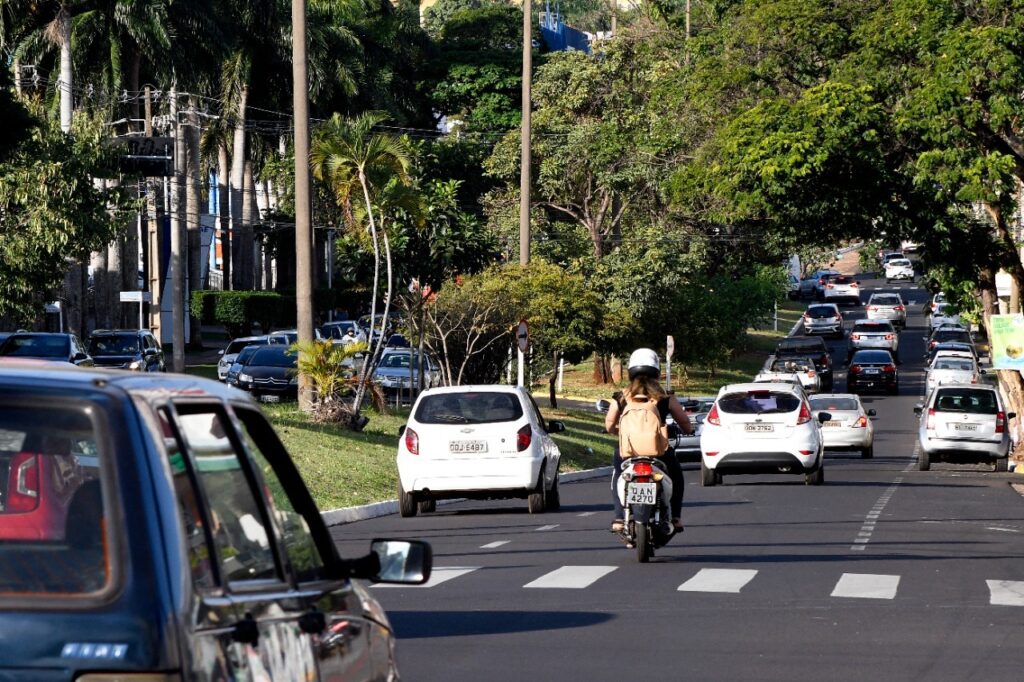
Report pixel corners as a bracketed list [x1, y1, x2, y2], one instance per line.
[397, 385, 565, 516]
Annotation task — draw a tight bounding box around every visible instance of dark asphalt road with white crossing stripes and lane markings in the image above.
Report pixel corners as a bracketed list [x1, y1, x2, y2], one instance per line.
[335, 274, 1024, 682]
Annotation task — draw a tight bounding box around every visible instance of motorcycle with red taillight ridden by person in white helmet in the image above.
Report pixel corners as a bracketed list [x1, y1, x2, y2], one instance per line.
[597, 400, 676, 563]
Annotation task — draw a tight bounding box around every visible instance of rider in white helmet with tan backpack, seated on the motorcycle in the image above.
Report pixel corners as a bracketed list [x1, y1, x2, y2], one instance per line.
[604, 348, 693, 532]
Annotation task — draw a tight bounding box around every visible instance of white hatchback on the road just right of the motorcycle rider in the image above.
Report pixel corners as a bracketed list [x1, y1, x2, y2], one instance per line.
[700, 383, 831, 485]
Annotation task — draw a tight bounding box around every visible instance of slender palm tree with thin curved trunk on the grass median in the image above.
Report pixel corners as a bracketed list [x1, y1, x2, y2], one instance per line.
[310, 112, 413, 424]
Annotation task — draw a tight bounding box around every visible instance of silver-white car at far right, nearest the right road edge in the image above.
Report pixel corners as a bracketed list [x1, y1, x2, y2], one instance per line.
[913, 385, 1017, 471]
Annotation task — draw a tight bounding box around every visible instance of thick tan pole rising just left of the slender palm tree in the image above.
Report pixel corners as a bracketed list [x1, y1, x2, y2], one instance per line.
[292, 0, 313, 412]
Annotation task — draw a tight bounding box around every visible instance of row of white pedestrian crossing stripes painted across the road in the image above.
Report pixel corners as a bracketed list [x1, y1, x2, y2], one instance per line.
[374, 565, 1024, 606]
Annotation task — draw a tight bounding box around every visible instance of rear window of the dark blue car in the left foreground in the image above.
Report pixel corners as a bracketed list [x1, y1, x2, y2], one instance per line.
[0, 403, 111, 598]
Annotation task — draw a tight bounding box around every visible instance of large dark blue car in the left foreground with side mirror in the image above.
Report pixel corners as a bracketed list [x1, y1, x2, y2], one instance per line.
[0, 358, 432, 682]
